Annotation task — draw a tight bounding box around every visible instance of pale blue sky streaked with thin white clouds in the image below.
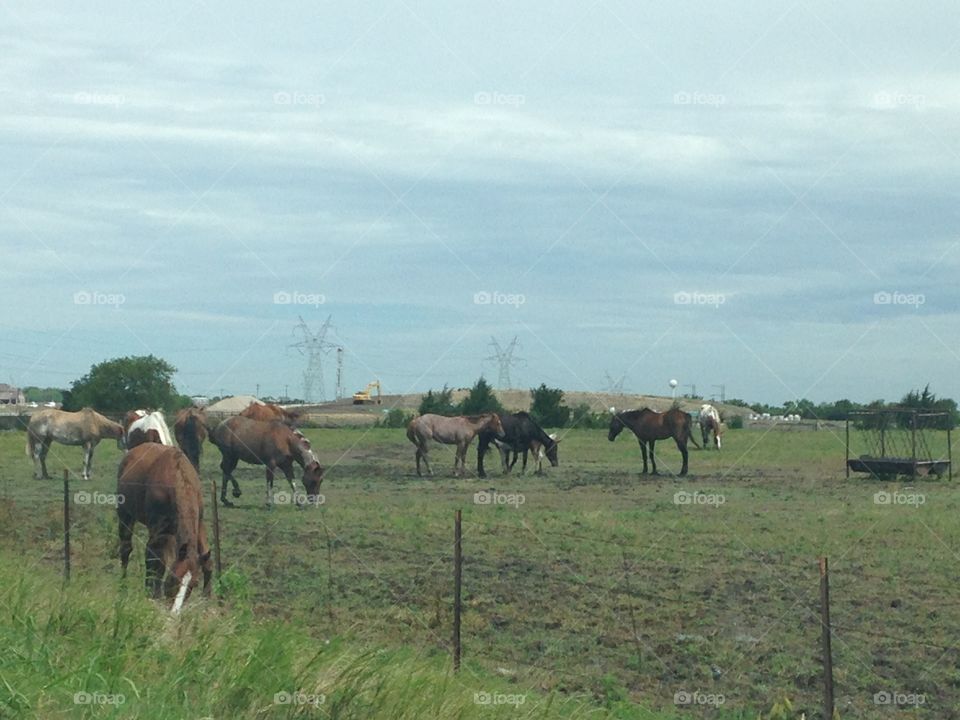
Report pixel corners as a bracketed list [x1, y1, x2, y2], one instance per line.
[0, 0, 960, 403]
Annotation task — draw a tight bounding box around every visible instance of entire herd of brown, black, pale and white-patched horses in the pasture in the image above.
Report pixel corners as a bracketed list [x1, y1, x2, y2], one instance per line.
[18, 404, 721, 598]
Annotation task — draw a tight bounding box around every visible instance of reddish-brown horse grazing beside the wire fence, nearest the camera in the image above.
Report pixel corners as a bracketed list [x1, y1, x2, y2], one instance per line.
[117, 443, 212, 598]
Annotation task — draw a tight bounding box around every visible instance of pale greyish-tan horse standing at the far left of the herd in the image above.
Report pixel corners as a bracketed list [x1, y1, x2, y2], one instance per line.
[26, 408, 123, 480]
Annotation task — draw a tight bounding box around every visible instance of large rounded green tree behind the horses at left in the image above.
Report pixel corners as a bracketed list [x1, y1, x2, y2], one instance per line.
[64, 355, 182, 413]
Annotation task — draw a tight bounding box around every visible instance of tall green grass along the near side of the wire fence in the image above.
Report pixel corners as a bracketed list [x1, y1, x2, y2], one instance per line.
[0, 558, 664, 720]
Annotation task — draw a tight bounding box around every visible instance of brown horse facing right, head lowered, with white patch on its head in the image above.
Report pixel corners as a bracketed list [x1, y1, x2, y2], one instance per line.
[209, 415, 324, 508]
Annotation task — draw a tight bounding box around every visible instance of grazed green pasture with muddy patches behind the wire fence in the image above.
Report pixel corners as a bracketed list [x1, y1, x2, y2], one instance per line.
[0, 429, 960, 719]
